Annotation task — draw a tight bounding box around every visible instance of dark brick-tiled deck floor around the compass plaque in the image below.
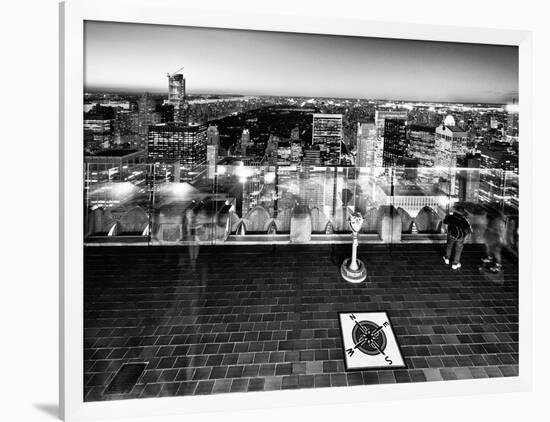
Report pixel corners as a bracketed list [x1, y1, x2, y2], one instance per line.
[84, 245, 518, 401]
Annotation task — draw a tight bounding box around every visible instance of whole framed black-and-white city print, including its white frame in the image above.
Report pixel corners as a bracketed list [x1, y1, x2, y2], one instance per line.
[60, 0, 532, 420]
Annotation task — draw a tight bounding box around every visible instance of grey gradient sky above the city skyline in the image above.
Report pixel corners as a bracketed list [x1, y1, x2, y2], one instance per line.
[84, 22, 518, 103]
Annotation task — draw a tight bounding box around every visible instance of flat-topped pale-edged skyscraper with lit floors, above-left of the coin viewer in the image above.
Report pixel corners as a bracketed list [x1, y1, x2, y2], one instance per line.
[311, 113, 343, 166]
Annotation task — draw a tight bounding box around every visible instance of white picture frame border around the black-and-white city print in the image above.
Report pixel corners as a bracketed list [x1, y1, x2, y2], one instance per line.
[59, 0, 533, 421]
